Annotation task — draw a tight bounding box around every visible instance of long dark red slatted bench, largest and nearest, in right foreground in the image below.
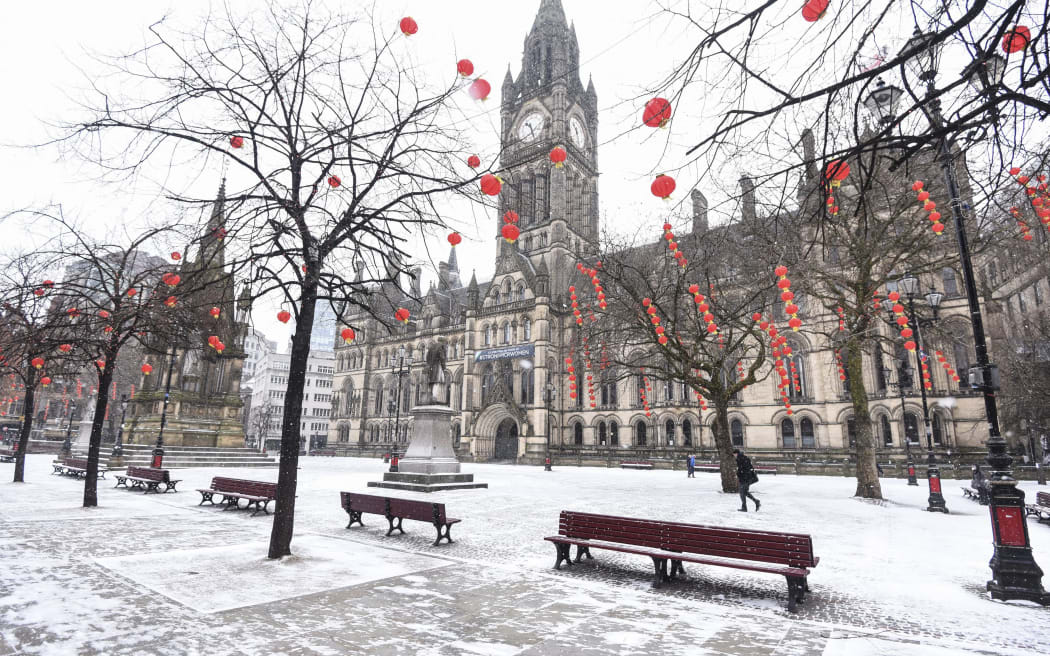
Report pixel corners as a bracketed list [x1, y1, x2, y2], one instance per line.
[544, 510, 820, 612]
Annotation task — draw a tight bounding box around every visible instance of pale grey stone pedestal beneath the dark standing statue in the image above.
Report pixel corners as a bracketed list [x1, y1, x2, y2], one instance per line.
[369, 405, 488, 492]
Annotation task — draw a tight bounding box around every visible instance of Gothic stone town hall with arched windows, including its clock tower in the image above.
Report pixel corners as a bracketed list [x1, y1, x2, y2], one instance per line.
[328, 0, 987, 464]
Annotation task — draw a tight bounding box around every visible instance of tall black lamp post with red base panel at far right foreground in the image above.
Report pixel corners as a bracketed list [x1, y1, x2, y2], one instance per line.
[865, 27, 1050, 606]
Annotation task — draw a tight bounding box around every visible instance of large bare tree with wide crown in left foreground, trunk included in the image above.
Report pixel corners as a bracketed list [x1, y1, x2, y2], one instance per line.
[68, 1, 487, 558]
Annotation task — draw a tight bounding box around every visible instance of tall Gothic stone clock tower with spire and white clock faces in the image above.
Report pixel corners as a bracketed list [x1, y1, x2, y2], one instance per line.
[496, 0, 599, 296]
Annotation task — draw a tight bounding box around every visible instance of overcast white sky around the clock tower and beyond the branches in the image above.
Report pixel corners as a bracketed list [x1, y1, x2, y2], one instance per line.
[0, 0, 999, 344]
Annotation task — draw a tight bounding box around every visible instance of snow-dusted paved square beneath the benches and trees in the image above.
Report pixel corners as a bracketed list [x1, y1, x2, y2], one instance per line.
[0, 456, 1050, 656]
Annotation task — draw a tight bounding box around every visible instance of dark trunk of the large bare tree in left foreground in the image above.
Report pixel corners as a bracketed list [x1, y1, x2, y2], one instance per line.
[269, 281, 317, 558]
